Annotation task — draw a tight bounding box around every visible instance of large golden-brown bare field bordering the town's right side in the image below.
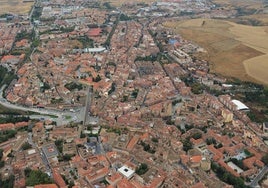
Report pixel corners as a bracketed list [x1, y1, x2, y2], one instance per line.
[164, 19, 268, 85]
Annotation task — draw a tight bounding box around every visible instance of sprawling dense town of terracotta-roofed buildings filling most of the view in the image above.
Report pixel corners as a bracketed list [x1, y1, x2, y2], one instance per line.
[0, 0, 268, 188]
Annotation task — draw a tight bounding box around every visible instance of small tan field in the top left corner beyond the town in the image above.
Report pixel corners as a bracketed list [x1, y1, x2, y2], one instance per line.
[0, 0, 33, 15]
